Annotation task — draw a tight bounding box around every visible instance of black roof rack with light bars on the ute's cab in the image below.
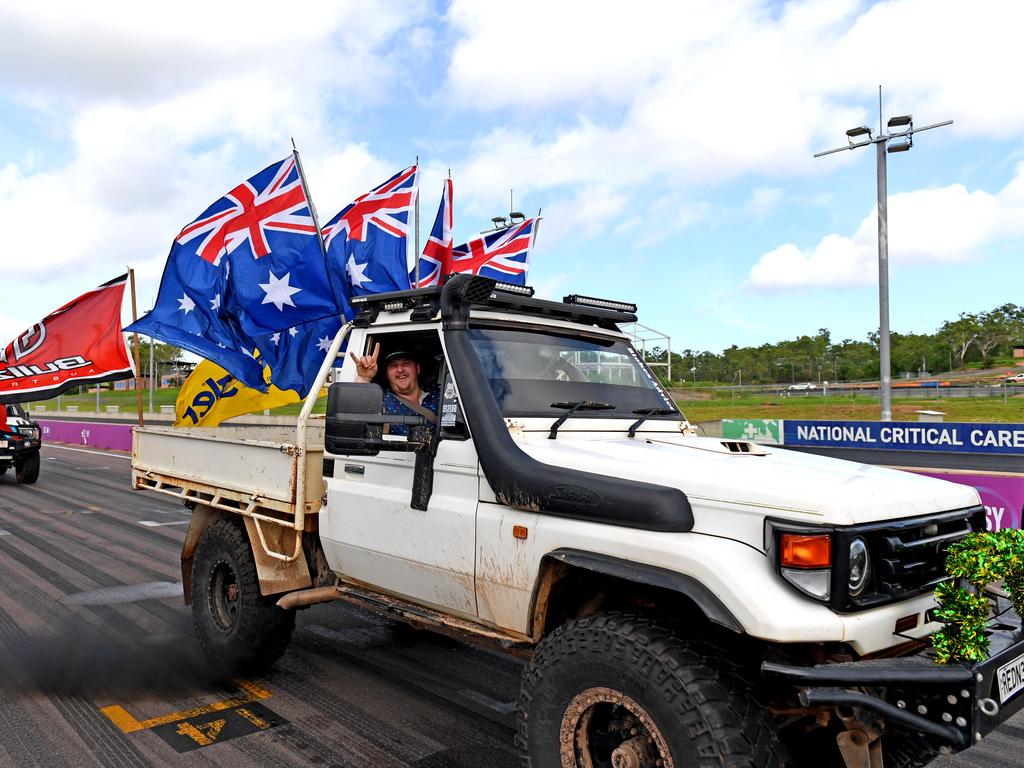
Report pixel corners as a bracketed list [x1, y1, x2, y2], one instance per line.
[349, 274, 637, 331]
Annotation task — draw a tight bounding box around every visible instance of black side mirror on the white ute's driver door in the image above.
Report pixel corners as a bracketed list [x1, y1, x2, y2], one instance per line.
[324, 382, 430, 456]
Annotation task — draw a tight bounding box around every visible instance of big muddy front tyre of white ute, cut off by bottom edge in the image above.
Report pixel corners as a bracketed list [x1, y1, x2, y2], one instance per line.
[517, 612, 785, 768]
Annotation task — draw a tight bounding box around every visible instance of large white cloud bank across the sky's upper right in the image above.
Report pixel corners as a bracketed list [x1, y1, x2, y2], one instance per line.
[445, 0, 1024, 217]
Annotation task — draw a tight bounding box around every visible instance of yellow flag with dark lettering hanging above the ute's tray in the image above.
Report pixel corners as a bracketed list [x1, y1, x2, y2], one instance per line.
[174, 360, 302, 427]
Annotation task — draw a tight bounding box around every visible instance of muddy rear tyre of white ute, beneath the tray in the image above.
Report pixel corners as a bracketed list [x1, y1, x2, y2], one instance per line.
[191, 518, 295, 670]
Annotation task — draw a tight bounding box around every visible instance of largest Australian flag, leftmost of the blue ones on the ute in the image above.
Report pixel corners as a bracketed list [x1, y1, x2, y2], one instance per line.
[126, 155, 341, 391]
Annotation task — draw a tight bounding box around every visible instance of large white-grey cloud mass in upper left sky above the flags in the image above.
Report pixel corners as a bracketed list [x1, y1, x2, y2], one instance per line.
[0, 0, 423, 296]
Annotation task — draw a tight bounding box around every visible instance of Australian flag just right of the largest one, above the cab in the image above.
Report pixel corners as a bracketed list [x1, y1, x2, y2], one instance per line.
[324, 165, 419, 296]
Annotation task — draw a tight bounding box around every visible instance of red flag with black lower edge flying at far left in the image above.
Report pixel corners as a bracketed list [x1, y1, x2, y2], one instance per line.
[0, 274, 135, 402]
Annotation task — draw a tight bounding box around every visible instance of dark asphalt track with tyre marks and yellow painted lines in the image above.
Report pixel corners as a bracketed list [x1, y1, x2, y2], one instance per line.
[0, 445, 1024, 768]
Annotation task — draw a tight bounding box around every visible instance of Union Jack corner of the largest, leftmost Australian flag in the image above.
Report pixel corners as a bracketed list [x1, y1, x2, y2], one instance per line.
[175, 156, 316, 266]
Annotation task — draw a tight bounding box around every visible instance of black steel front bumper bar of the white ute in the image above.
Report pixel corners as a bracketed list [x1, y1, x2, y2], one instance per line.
[761, 609, 1024, 750]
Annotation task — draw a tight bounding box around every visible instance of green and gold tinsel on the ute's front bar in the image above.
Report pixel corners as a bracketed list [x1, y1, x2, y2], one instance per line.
[932, 528, 1024, 664]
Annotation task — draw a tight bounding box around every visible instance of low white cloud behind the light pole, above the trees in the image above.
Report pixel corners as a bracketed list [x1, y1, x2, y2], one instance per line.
[745, 179, 1007, 290]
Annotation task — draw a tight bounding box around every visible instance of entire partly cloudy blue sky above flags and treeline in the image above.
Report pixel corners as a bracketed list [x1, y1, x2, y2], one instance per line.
[0, 0, 1024, 358]
